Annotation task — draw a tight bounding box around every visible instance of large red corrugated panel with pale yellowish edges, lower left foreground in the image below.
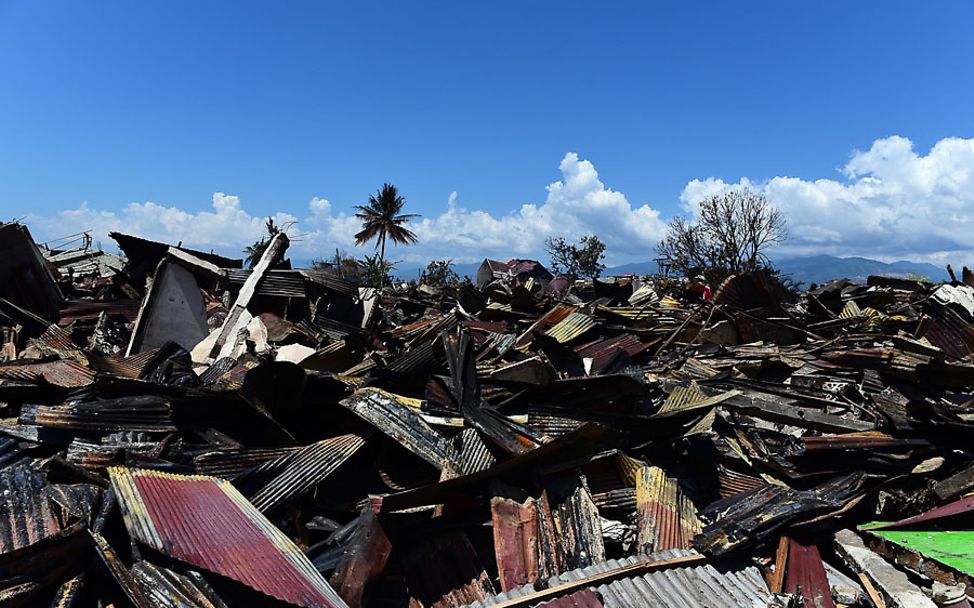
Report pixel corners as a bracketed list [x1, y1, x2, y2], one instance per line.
[109, 467, 345, 608]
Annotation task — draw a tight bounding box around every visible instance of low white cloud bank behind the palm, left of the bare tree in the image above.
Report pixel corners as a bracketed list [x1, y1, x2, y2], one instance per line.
[27, 152, 665, 262]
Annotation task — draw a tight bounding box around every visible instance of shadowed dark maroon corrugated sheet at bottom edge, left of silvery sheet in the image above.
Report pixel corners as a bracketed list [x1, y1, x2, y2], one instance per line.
[403, 531, 495, 608]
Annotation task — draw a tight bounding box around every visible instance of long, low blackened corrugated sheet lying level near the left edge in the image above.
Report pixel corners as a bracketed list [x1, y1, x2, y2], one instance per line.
[20, 395, 176, 432]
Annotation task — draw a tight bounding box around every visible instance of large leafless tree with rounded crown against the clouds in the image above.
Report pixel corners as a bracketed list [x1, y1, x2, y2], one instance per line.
[656, 188, 788, 287]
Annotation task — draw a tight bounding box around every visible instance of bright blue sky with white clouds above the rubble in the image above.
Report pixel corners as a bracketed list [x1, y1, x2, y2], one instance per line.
[0, 0, 974, 261]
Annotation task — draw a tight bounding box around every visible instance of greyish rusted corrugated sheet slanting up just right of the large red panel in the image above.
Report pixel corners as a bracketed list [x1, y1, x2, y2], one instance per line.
[237, 434, 365, 512]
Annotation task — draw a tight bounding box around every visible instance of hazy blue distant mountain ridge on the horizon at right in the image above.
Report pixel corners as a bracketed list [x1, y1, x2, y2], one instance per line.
[604, 255, 948, 287]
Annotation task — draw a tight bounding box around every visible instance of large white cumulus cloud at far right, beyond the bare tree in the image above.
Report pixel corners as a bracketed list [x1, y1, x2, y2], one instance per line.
[680, 136, 974, 261]
